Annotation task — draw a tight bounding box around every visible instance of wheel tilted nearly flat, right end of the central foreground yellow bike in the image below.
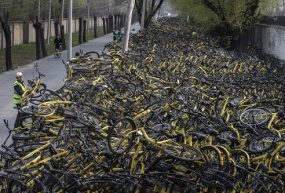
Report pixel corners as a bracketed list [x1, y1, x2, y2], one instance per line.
[162, 144, 202, 161]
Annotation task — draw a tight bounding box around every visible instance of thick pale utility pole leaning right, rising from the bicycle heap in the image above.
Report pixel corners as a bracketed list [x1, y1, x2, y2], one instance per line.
[123, 0, 135, 52]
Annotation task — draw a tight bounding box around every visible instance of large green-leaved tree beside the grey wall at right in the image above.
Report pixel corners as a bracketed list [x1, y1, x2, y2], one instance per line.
[170, 0, 278, 48]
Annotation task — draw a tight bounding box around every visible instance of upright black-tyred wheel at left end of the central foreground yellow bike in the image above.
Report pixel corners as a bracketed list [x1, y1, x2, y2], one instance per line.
[107, 118, 136, 154]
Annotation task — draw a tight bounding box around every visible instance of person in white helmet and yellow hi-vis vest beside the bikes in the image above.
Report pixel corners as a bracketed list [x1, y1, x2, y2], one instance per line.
[13, 72, 28, 128]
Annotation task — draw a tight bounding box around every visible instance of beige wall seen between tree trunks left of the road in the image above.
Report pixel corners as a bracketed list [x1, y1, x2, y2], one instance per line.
[0, 17, 103, 49]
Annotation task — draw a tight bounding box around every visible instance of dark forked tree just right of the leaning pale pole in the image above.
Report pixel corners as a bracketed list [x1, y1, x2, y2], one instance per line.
[135, 0, 164, 28]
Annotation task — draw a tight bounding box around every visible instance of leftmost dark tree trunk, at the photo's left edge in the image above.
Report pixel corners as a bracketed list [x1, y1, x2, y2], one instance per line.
[0, 12, 12, 71]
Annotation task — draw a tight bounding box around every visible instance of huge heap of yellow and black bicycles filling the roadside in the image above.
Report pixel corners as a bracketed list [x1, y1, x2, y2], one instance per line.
[0, 18, 285, 193]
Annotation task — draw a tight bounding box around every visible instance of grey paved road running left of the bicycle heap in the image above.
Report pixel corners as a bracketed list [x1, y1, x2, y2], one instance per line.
[0, 23, 140, 144]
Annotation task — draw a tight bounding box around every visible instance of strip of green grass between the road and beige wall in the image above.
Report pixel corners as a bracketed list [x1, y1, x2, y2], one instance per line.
[0, 27, 103, 73]
